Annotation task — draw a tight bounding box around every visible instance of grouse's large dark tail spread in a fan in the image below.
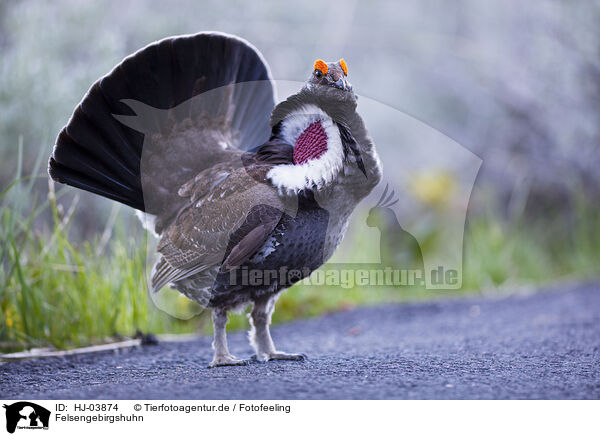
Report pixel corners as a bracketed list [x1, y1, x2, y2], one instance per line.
[48, 32, 275, 215]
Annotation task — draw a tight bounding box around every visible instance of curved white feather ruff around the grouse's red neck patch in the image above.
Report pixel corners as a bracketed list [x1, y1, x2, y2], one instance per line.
[267, 105, 344, 194]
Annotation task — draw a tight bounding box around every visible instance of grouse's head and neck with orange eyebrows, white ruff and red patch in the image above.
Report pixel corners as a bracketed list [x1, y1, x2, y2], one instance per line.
[268, 59, 366, 192]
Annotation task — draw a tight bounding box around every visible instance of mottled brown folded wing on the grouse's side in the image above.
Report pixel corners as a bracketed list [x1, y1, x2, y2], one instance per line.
[152, 165, 290, 290]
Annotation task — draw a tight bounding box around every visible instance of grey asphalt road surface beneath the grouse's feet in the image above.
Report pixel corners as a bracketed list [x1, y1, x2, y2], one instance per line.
[0, 283, 600, 399]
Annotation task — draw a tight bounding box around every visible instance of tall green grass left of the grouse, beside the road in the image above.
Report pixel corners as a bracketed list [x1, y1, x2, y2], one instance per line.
[0, 143, 202, 350]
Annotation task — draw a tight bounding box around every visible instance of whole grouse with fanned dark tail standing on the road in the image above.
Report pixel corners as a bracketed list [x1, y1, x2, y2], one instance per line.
[48, 32, 382, 367]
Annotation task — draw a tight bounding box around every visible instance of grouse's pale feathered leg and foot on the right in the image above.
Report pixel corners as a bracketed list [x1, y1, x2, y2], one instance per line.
[249, 297, 306, 361]
